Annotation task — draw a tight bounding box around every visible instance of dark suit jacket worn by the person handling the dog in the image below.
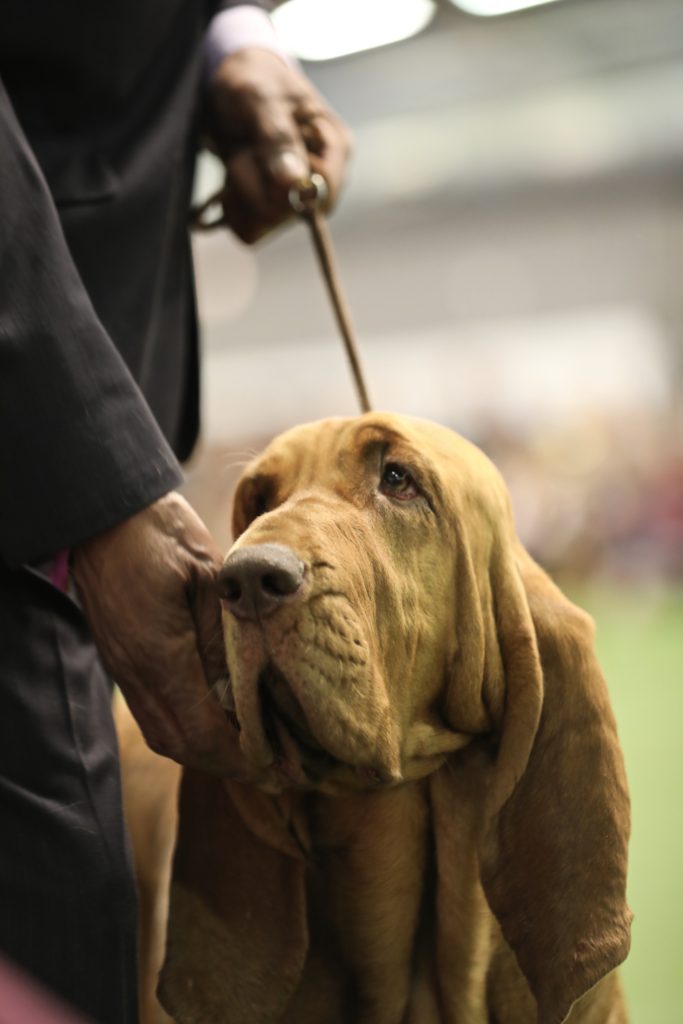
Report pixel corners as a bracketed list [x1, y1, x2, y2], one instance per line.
[0, 0, 268, 565]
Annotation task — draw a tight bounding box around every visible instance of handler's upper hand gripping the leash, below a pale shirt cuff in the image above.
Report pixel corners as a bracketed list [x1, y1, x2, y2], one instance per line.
[210, 47, 350, 243]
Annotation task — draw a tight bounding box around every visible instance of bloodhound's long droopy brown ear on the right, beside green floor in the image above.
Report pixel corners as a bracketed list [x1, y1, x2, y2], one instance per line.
[480, 547, 631, 1024]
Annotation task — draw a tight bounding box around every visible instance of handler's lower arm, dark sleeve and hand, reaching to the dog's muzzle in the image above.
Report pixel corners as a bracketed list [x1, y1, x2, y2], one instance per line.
[0, 83, 242, 777]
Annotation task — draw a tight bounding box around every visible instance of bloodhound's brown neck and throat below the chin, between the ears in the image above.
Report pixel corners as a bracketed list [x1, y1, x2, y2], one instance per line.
[219, 754, 492, 1024]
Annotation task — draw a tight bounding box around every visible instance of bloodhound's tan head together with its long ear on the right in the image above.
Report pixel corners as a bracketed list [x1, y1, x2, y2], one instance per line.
[211, 414, 629, 1024]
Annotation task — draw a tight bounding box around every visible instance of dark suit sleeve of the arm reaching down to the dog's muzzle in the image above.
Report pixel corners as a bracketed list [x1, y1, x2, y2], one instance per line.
[0, 82, 180, 566]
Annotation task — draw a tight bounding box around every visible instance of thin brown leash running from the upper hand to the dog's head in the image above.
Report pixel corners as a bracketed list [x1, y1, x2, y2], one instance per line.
[191, 174, 372, 413]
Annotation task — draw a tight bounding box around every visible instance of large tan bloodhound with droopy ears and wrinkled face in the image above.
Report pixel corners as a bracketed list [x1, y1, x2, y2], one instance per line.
[116, 414, 631, 1024]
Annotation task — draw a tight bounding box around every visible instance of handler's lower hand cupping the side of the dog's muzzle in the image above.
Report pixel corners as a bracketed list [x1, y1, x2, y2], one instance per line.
[73, 494, 246, 778]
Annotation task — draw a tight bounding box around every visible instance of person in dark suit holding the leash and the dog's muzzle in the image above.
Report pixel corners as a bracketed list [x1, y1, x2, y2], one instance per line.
[0, 0, 349, 1024]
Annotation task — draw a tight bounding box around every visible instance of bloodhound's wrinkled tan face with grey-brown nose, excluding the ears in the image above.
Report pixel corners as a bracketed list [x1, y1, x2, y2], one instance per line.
[220, 414, 508, 790]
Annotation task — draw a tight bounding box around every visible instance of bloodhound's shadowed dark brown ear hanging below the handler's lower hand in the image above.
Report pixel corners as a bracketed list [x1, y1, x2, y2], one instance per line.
[159, 769, 308, 1024]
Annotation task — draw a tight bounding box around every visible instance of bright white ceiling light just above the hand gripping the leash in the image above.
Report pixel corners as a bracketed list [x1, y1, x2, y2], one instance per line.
[272, 0, 436, 60]
